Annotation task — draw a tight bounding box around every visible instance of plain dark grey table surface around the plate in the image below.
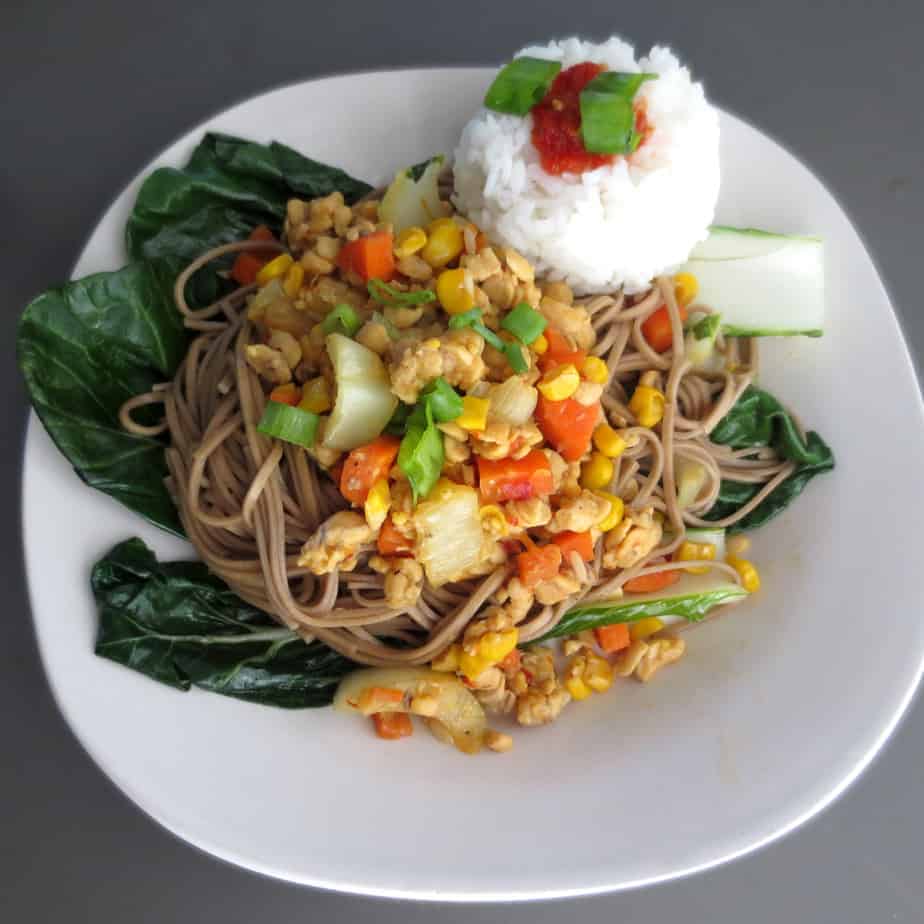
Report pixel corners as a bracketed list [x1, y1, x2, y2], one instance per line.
[0, 0, 924, 924]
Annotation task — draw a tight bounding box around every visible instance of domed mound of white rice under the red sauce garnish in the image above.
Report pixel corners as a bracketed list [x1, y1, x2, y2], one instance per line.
[455, 38, 719, 294]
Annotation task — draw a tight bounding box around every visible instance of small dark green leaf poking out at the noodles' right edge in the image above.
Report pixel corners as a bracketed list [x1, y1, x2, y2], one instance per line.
[705, 385, 834, 532]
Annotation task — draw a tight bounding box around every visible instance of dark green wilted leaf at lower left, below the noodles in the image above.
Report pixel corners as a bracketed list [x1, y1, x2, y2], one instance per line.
[91, 539, 356, 709]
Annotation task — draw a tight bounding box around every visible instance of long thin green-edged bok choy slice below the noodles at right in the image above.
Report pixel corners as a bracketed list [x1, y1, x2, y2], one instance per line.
[539, 530, 748, 641]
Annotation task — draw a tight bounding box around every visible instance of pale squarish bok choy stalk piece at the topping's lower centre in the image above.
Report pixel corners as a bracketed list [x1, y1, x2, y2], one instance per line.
[414, 478, 481, 587]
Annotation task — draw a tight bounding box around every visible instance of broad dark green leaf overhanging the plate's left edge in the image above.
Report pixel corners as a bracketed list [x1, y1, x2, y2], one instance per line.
[16, 260, 187, 535]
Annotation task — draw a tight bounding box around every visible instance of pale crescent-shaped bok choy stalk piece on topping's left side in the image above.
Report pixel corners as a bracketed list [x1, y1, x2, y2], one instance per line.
[323, 334, 398, 450]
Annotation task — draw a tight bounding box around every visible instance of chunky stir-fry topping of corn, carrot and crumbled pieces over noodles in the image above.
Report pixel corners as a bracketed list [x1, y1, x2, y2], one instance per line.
[232, 170, 760, 750]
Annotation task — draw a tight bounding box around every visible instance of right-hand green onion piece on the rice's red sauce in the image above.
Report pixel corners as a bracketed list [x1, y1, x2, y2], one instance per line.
[580, 71, 657, 154]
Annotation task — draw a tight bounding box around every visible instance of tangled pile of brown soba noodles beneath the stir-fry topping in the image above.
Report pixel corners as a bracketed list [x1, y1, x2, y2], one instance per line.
[122, 212, 792, 665]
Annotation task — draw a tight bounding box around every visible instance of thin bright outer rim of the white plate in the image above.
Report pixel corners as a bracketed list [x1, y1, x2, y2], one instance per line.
[19, 65, 924, 904]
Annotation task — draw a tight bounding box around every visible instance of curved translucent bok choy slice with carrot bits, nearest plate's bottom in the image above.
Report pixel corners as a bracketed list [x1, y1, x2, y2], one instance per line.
[334, 667, 487, 754]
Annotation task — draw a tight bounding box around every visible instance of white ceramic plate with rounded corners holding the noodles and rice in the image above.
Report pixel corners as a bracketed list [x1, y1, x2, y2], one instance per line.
[23, 69, 924, 901]
